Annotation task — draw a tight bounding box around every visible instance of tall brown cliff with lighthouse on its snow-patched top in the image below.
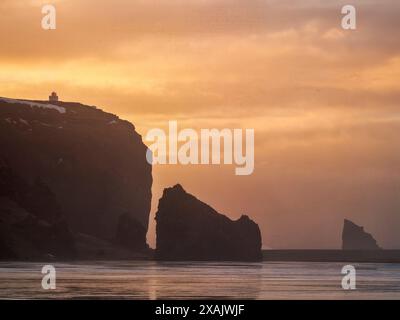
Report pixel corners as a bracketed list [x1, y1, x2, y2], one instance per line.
[0, 98, 152, 258]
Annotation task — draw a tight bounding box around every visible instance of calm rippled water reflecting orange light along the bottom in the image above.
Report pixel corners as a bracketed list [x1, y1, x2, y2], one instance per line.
[0, 261, 400, 299]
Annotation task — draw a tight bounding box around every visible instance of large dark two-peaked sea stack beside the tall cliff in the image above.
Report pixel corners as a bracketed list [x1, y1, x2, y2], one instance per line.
[156, 185, 261, 261]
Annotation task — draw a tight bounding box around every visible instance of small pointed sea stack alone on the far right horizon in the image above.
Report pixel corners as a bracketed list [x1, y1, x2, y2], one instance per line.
[342, 219, 381, 250]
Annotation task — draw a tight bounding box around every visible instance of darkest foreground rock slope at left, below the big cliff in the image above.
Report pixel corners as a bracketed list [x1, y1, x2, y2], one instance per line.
[0, 166, 76, 259]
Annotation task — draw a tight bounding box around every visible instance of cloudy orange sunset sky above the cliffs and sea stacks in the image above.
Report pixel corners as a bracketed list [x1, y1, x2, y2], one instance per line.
[0, 0, 400, 249]
